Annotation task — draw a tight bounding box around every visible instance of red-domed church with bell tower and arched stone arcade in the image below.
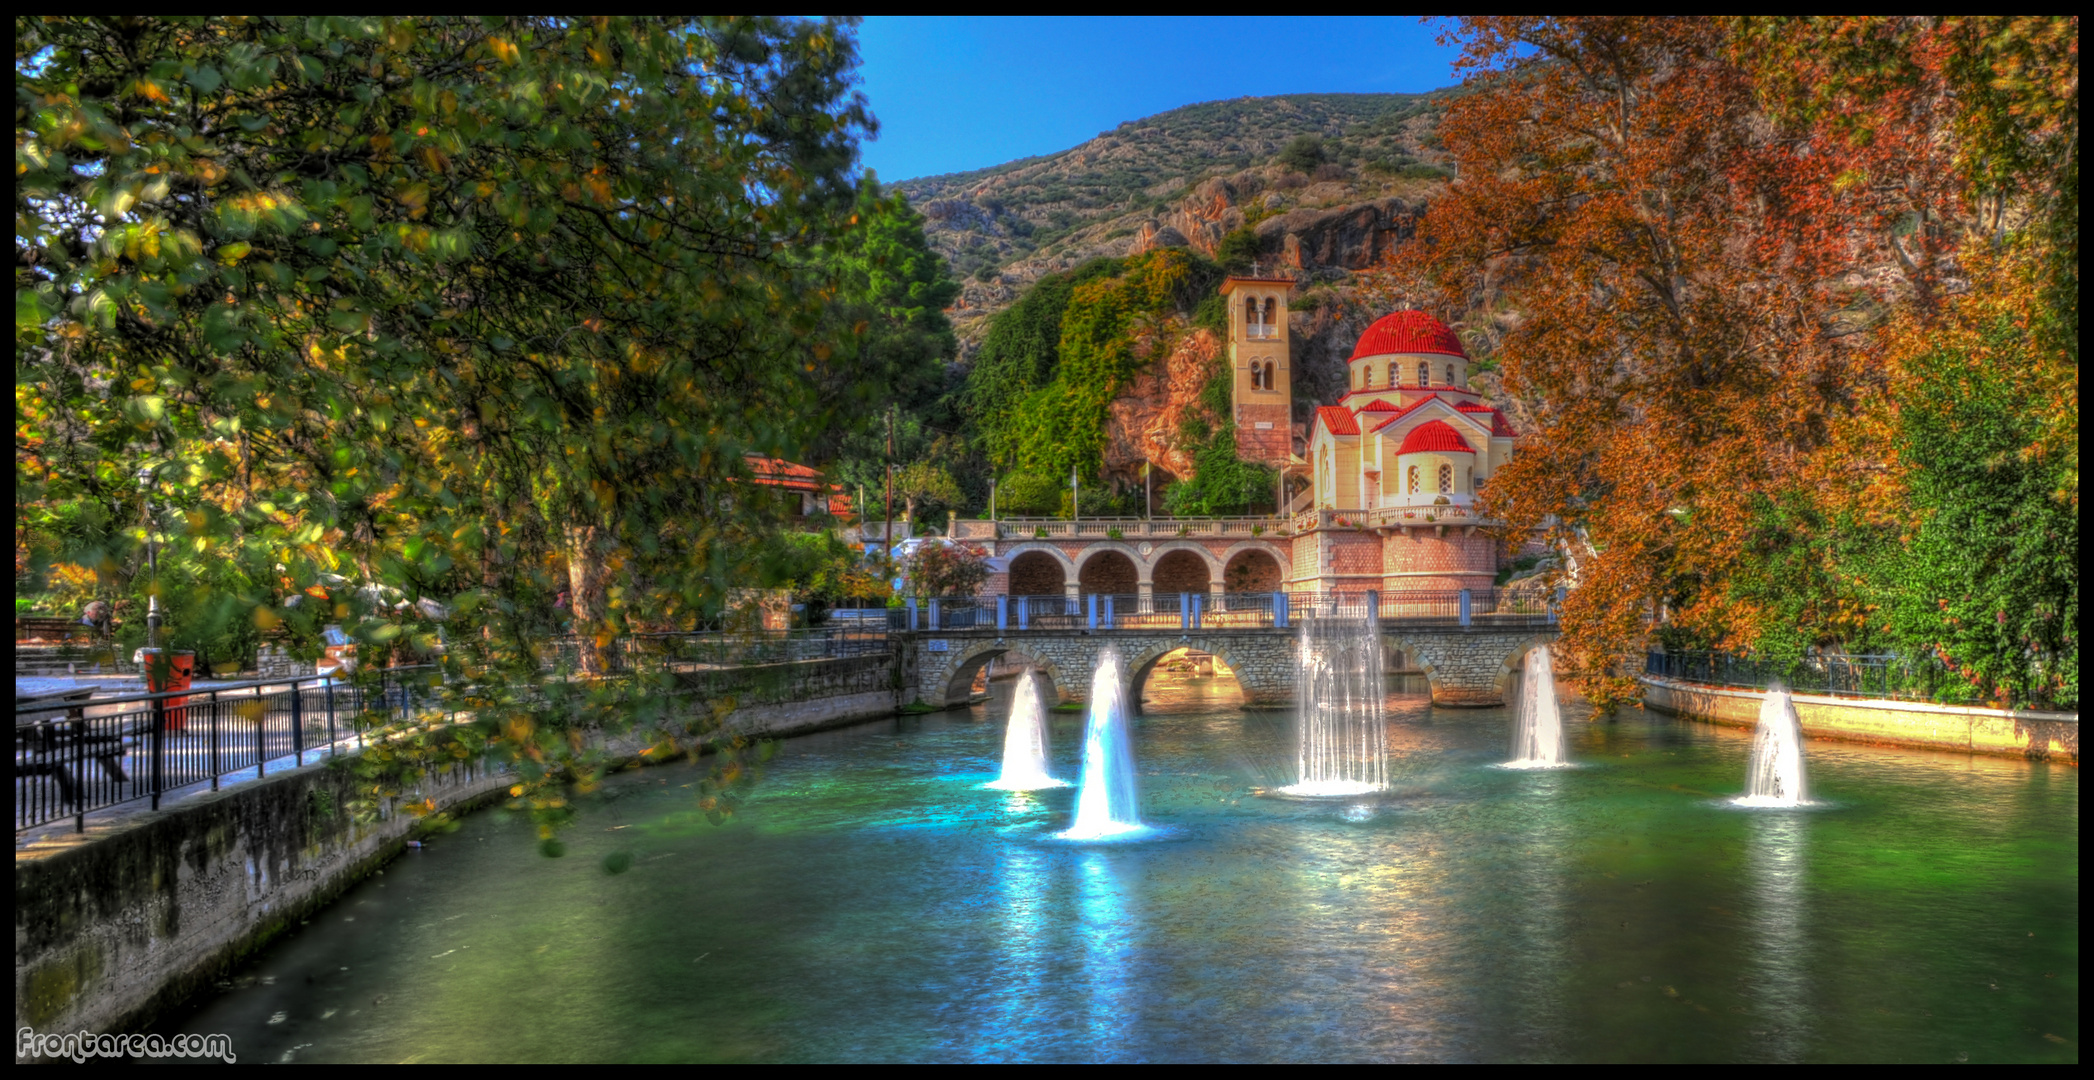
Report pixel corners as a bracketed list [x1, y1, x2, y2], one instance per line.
[942, 276, 1516, 611]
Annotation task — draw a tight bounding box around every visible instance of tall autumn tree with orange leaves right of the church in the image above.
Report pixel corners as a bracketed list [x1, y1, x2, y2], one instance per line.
[1382, 17, 2077, 705]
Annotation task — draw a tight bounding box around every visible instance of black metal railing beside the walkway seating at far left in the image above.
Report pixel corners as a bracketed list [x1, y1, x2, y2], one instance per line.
[15, 668, 442, 833]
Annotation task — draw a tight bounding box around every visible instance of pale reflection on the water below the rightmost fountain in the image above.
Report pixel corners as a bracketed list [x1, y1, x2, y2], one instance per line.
[1744, 814, 1813, 1061]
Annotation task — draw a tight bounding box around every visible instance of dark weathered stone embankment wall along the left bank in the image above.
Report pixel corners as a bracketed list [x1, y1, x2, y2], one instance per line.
[15, 657, 896, 1050]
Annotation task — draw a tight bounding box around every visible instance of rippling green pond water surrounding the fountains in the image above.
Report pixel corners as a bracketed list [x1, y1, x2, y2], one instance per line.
[163, 676, 2079, 1061]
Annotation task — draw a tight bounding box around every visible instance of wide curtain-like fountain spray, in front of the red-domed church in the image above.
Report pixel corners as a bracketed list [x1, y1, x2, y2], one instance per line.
[1279, 609, 1388, 797]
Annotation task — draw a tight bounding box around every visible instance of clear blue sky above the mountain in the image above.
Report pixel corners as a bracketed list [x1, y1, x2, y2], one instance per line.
[859, 15, 1457, 182]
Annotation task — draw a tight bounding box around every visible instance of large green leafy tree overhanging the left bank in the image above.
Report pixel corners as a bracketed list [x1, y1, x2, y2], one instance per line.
[15, 17, 884, 841]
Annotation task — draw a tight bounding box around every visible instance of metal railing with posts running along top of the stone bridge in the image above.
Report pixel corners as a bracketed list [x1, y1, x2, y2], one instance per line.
[894, 588, 1560, 632]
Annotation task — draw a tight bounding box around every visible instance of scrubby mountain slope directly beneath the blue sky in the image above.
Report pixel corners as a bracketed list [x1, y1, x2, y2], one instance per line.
[896, 90, 1453, 341]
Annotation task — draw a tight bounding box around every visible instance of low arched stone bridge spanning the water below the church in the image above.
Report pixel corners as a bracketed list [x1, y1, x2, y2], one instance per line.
[900, 624, 1556, 712]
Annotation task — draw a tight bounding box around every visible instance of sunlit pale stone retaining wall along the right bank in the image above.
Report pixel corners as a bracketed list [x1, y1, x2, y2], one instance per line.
[1642, 676, 2079, 766]
